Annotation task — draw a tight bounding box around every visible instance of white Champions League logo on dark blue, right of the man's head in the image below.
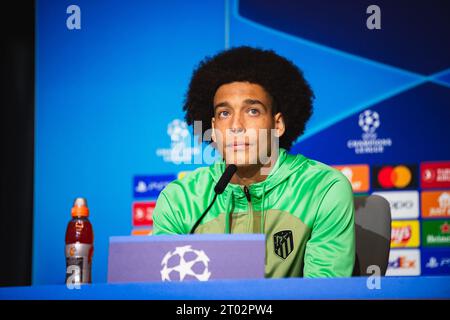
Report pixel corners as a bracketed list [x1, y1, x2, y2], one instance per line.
[347, 109, 392, 154]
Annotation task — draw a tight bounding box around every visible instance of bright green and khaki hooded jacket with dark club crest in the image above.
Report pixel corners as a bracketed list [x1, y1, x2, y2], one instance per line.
[153, 148, 355, 278]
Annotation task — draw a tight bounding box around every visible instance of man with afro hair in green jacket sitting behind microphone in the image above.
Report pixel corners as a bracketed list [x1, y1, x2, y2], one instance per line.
[153, 46, 355, 278]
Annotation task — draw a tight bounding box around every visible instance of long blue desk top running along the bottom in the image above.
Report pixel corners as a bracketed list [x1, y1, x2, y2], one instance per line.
[0, 276, 450, 300]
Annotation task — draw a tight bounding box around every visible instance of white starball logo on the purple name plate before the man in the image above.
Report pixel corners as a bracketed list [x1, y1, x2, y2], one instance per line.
[161, 245, 211, 281]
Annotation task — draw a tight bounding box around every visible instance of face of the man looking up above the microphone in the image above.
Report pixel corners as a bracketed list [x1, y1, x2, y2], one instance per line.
[212, 82, 284, 166]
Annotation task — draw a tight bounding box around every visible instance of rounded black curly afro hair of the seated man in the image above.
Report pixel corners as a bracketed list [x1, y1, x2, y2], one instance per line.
[183, 46, 314, 150]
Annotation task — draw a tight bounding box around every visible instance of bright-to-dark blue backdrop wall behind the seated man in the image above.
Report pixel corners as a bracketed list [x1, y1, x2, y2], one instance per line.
[33, 0, 450, 284]
